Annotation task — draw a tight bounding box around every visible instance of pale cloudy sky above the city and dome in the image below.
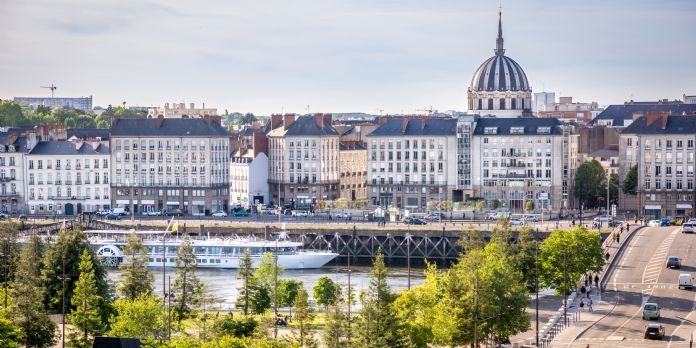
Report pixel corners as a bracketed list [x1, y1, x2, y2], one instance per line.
[0, 0, 696, 115]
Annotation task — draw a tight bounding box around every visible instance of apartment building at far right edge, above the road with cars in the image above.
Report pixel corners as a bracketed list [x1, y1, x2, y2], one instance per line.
[619, 112, 696, 219]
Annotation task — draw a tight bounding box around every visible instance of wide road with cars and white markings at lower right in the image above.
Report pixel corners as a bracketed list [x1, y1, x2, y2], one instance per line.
[570, 226, 696, 348]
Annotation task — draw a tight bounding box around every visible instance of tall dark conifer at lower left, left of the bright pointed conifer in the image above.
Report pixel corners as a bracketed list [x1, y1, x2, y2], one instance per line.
[10, 235, 56, 347]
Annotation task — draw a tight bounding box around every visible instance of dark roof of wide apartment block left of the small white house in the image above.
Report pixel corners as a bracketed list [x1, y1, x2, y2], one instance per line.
[110, 118, 229, 137]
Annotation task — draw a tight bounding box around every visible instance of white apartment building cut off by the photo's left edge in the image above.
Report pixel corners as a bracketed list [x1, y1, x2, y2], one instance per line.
[0, 129, 27, 214]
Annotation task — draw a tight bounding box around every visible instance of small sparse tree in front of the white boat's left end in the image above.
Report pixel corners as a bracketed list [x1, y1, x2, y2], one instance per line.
[118, 233, 154, 300]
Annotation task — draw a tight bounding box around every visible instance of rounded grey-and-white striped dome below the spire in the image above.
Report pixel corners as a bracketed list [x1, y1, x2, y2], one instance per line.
[471, 54, 531, 91]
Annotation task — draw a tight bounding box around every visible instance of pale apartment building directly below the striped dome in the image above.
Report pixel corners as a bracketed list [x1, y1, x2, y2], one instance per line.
[471, 118, 569, 213]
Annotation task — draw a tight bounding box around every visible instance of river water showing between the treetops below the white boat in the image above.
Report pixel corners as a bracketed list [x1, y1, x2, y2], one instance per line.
[108, 266, 424, 310]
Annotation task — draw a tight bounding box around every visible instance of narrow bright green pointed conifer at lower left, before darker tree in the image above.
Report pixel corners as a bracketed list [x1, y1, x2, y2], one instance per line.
[68, 250, 104, 347]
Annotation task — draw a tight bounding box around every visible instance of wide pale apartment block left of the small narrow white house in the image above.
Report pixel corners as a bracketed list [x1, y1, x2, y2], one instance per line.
[111, 116, 230, 216]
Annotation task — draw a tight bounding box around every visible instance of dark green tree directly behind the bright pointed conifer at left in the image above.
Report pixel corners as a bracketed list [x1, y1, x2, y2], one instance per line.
[41, 229, 113, 322]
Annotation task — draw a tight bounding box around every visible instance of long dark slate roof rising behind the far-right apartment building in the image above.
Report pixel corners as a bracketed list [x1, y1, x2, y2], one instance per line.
[590, 102, 696, 127]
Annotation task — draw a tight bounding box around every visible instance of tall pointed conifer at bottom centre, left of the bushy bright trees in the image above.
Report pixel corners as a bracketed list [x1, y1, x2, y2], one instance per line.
[355, 249, 408, 348]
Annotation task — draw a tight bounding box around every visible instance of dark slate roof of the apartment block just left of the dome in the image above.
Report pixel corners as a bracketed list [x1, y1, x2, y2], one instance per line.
[367, 117, 457, 137]
